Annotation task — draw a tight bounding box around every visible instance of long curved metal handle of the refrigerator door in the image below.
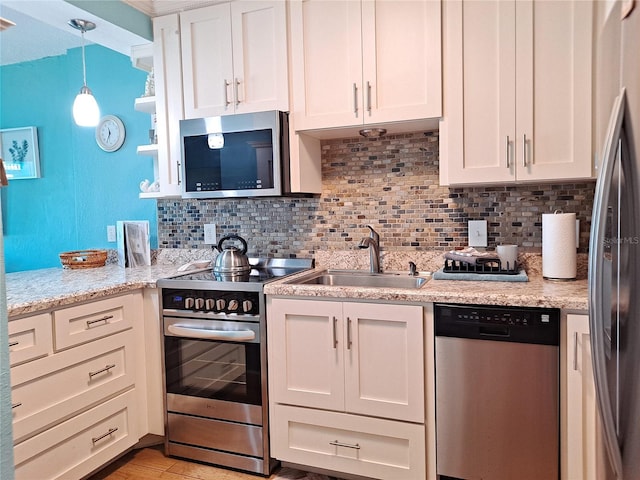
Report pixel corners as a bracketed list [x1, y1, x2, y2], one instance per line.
[589, 89, 626, 480]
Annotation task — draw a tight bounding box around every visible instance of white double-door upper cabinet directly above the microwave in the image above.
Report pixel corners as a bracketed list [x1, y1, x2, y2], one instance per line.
[180, 0, 289, 118]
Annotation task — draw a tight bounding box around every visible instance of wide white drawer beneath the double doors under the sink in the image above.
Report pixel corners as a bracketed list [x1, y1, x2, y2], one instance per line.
[271, 405, 426, 480]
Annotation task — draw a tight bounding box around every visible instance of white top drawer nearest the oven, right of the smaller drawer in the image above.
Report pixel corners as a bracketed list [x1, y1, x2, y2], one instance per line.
[53, 295, 134, 351]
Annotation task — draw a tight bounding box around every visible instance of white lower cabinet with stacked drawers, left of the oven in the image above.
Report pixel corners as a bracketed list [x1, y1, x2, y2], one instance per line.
[9, 292, 145, 480]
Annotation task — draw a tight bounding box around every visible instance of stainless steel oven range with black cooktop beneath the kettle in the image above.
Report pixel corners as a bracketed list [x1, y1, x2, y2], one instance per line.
[158, 259, 313, 476]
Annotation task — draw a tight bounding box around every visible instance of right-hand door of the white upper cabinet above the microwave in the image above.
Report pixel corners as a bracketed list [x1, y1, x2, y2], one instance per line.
[231, 0, 289, 113]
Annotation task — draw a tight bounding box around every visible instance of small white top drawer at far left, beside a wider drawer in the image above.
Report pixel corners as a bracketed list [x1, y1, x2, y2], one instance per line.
[9, 313, 53, 366]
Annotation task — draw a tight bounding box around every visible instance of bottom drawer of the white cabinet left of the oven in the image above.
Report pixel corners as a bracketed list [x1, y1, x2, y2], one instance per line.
[13, 390, 138, 480]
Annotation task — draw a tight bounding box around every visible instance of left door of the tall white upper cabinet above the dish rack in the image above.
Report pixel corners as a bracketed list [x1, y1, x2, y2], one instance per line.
[440, 1, 516, 185]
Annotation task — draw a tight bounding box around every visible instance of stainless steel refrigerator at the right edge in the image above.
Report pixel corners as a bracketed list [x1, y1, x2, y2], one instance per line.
[589, 0, 640, 480]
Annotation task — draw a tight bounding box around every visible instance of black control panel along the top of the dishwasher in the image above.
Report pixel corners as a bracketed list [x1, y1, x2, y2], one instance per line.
[434, 303, 560, 345]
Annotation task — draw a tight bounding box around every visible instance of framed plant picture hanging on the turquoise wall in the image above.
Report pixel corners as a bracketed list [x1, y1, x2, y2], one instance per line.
[0, 127, 40, 180]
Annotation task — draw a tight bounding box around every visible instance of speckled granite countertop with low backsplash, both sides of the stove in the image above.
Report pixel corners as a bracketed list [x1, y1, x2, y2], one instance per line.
[6, 249, 588, 317]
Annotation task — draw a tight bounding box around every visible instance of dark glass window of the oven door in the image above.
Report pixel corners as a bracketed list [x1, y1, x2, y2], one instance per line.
[164, 337, 262, 405]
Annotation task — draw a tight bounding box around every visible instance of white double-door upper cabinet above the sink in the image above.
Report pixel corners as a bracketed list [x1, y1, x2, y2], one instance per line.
[290, 0, 442, 130]
